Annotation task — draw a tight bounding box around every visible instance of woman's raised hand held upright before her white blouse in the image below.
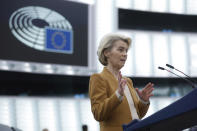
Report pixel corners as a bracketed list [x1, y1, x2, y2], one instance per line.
[118, 72, 127, 96]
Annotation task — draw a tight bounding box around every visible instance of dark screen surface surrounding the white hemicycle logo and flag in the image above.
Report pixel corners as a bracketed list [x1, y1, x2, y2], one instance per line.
[0, 0, 88, 66]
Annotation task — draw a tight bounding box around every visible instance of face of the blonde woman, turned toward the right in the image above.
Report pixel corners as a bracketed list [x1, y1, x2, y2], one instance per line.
[105, 40, 129, 69]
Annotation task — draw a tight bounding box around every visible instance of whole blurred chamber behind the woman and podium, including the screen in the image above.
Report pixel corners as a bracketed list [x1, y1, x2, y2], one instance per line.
[0, 0, 197, 131]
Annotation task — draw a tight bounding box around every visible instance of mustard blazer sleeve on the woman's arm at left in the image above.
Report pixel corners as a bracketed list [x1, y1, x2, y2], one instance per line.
[89, 74, 121, 121]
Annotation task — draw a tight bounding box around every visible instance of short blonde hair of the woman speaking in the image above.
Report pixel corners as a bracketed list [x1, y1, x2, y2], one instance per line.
[97, 33, 131, 66]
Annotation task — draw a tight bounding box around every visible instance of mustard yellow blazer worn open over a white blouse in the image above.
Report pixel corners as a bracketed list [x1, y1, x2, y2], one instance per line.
[89, 67, 149, 131]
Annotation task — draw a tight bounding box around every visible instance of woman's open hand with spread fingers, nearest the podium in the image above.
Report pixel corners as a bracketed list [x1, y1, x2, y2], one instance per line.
[136, 82, 154, 101]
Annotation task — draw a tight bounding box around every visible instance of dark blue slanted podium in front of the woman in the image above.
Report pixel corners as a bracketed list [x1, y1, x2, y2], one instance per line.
[123, 88, 197, 131]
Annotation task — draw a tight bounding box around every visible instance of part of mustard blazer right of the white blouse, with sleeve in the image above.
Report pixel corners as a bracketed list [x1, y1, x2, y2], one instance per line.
[128, 78, 150, 119]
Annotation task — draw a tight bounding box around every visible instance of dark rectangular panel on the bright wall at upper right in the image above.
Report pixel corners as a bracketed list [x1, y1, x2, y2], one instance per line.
[118, 9, 197, 32]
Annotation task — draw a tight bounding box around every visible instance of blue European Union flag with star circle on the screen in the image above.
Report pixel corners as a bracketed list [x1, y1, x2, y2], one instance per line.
[45, 28, 73, 54]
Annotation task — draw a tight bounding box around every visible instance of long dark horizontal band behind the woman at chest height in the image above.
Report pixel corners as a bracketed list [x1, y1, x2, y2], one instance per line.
[0, 71, 197, 96]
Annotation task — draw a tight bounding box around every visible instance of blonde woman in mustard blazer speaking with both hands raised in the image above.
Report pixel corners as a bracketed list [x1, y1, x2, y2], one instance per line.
[89, 34, 154, 131]
